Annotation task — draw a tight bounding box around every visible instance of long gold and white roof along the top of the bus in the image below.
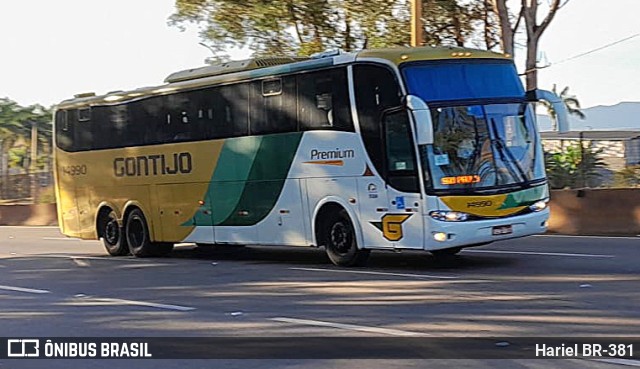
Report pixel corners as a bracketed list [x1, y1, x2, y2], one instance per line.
[57, 46, 510, 109]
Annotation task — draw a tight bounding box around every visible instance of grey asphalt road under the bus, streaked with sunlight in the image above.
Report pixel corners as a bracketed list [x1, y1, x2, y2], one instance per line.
[0, 227, 640, 368]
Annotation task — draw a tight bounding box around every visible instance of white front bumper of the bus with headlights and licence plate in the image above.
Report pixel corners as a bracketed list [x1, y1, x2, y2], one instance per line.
[424, 208, 549, 251]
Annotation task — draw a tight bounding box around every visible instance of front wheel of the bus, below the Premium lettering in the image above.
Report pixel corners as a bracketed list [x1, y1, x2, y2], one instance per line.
[323, 209, 371, 267]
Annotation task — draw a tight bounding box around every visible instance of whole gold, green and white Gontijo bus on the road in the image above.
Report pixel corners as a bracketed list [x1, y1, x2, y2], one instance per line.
[54, 47, 566, 266]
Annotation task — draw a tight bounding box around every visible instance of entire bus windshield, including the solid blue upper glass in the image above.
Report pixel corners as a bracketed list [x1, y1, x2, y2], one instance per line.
[403, 60, 545, 191]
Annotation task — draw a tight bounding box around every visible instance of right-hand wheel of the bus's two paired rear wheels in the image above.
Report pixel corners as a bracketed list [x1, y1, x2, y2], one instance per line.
[125, 209, 173, 257]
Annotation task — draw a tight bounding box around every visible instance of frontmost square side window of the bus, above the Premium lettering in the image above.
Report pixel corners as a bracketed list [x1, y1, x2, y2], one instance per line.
[298, 68, 354, 132]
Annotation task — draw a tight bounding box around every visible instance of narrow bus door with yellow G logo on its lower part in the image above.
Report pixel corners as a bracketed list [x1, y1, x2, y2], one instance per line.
[382, 109, 424, 249]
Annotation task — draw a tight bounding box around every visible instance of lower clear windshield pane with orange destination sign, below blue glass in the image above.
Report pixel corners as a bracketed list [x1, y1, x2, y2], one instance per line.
[420, 103, 544, 190]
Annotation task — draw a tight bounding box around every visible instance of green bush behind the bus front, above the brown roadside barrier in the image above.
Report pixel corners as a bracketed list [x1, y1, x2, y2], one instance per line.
[545, 143, 606, 189]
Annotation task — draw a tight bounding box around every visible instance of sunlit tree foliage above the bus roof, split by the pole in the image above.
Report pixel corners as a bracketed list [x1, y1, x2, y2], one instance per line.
[169, 0, 498, 56]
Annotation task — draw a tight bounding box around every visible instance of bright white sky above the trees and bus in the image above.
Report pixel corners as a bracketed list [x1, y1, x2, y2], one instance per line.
[0, 0, 640, 107]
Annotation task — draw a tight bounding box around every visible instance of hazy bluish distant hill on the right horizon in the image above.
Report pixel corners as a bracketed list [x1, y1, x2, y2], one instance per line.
[538, 102, 640, 131]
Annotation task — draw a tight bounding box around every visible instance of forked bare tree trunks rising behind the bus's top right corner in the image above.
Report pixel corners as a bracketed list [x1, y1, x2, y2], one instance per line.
[492, 0, 569, 90]
